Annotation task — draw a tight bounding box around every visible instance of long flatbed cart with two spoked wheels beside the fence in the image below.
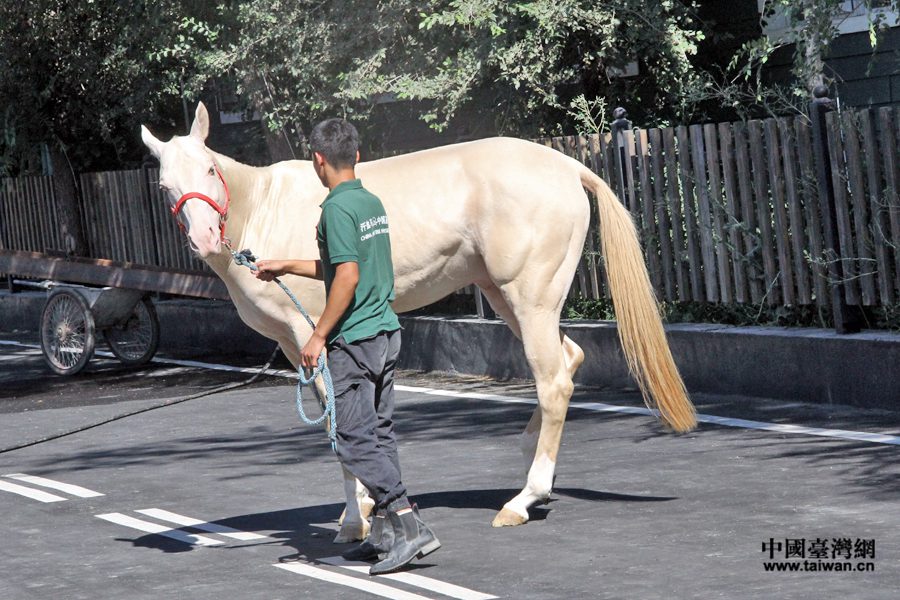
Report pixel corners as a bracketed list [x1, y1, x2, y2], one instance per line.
[0, 250, 228, 375]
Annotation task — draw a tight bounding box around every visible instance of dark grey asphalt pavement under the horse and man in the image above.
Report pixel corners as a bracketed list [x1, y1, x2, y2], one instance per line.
[0, 335, 900, 600]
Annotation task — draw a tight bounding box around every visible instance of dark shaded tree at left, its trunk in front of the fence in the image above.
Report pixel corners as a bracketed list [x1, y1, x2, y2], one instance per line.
[0, 0, 224, 254]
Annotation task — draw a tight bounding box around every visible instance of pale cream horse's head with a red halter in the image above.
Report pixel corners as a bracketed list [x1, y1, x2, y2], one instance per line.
[141, 102, 229, 259]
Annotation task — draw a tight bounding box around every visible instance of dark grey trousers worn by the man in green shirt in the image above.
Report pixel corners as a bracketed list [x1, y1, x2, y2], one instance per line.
[328, 330, 409, 511]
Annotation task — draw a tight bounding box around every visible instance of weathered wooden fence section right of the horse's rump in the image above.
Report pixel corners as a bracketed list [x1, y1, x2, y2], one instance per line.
[539, 103, 900, 306]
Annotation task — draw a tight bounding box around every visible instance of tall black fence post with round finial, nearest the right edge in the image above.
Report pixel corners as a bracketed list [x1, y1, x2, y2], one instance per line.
[809, 85, 862, 334]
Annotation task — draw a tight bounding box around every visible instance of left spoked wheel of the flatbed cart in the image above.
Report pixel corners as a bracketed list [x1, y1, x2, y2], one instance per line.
[41, 290, 94, 375]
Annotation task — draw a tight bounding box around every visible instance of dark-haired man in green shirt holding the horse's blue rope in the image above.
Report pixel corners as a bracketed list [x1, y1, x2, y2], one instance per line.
[255, 119, 440, 575]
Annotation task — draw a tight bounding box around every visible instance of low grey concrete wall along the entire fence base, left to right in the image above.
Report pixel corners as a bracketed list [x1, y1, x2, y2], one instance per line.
[0, 293, 900, 409]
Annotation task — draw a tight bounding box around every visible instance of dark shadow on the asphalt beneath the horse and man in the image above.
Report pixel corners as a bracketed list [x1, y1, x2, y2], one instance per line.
[117, 488, 677, 568]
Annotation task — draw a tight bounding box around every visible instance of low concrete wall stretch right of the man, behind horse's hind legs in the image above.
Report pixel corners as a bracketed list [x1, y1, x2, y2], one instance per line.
[401, 317, 900, 409]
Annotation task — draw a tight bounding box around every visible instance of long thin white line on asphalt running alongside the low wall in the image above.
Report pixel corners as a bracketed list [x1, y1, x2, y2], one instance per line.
[0, 340, 900, 446]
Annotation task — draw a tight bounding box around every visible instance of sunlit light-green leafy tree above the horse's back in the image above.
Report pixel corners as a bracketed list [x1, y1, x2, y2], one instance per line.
[216, 0, 703, 135]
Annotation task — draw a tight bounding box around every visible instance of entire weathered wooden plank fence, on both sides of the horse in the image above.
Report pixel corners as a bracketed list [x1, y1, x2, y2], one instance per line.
[0, 108, 900, 306]
